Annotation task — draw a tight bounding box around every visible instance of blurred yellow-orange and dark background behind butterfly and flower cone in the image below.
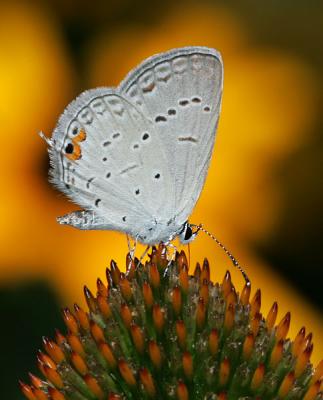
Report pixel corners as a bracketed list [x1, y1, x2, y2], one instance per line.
[0, 0, 323, 400]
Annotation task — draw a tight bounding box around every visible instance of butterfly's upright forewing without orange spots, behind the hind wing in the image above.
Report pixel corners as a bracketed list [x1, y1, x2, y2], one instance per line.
[119, 47, 223, 226]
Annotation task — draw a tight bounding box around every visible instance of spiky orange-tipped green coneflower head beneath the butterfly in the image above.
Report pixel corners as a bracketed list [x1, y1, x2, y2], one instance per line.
[21, 246, 323, 400]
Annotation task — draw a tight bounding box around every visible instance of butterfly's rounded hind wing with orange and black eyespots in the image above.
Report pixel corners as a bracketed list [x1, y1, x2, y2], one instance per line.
[49, 88, 175, 236]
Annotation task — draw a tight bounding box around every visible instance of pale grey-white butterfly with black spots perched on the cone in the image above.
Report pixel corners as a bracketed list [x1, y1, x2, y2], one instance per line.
[41, 47, 223, 245]
